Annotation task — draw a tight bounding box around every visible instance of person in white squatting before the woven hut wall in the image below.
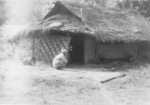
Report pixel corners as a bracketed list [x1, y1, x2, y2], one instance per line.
[52, 49, 68, 69]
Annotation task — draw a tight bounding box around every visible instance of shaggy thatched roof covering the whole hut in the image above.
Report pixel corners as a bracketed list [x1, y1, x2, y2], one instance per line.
[10, 1, 150, 42]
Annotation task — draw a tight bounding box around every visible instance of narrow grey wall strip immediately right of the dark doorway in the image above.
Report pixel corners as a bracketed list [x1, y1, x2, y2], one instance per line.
[84, 36, 96, 64]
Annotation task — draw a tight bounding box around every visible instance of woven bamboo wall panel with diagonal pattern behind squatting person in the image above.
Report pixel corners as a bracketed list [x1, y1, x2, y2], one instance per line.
[35, 35, 71, 63]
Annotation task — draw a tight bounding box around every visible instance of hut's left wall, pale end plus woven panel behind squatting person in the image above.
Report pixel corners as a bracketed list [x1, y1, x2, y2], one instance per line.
[15, 35, 70, 63]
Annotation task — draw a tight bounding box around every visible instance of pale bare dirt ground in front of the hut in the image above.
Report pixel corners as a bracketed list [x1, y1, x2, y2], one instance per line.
[0, 60, 150, 105]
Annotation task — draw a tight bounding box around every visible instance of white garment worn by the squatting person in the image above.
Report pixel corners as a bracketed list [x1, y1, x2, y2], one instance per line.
[52, 53, 68, 68]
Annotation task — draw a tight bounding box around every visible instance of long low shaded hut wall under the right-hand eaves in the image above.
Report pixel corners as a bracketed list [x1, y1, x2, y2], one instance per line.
[97, 42, 150, 59]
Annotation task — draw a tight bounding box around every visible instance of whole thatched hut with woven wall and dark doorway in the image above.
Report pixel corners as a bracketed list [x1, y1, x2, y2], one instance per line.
[11, 1, 150, 64]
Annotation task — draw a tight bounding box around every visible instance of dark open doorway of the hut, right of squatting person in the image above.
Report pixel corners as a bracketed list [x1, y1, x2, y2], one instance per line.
[70, 35, 84, 64]
